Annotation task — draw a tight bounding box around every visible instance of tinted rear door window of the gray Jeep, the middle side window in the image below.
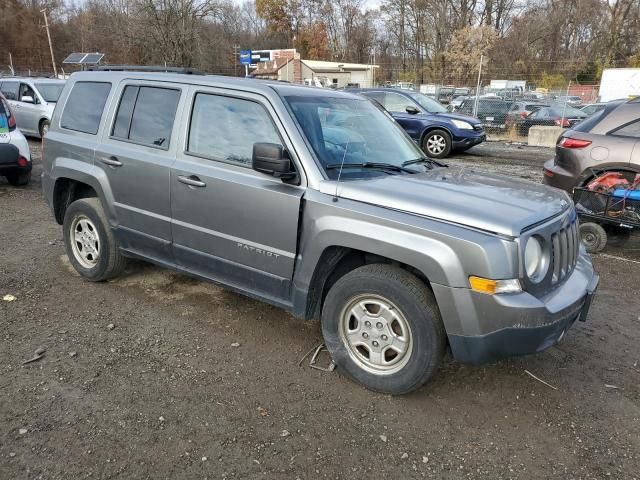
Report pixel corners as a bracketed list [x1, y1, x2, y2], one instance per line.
[112, 85, 180, 149]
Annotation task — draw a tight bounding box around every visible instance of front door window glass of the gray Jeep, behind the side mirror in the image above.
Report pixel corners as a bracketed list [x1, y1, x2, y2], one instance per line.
[187, 93, 282, 167]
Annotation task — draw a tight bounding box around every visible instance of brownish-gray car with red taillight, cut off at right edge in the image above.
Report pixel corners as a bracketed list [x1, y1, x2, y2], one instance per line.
[544, 100, 640, 191]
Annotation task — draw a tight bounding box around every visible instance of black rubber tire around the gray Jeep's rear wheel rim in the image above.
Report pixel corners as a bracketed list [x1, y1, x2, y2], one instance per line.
[62, 198, 126, 282]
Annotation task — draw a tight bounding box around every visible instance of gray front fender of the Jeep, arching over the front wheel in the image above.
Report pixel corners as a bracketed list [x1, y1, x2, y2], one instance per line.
[293, 191, 518, 318]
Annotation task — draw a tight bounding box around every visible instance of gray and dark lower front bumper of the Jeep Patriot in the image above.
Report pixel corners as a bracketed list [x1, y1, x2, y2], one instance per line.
[433, 249, 599, 364]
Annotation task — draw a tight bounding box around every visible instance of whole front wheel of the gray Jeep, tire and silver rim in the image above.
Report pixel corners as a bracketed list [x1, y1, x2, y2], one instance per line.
[322, 264, 446, 394]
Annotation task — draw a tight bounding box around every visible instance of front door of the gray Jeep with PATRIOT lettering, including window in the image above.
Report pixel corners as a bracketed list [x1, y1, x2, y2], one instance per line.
[171, 88, 304, 305]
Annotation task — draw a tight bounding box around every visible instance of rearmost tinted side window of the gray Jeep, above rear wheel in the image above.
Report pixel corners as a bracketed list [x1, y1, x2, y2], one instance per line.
[60, 82, 111, 135]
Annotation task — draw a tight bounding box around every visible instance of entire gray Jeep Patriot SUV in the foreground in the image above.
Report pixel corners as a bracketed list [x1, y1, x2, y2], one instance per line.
[42, 71, 598, 393]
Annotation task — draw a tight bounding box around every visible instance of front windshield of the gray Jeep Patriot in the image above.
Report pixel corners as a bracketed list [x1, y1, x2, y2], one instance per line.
[284, 95, 424, 179]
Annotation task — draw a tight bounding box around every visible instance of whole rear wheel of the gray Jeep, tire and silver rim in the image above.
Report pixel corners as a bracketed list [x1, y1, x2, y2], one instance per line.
[63, 198, 126, 282]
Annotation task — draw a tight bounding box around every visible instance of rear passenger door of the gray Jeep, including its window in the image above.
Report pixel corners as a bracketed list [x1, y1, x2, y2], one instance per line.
[95, 80, 187, 263]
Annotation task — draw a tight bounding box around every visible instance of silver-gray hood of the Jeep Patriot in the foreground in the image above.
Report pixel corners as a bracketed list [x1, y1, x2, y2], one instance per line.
[321, 167, 571, 237]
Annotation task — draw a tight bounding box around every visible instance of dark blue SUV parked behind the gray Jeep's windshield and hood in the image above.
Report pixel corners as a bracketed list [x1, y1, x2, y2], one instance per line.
[358, 89, 486, 158]
